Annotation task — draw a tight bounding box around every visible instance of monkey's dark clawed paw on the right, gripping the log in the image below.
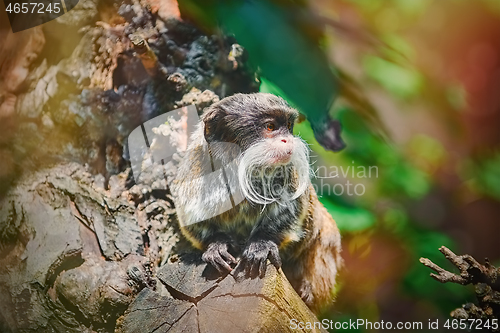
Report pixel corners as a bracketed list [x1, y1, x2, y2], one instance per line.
[240, 240, 281, 278]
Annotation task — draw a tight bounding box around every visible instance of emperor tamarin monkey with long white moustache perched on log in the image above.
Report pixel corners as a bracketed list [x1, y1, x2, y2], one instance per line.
[172, 93, 342, 312]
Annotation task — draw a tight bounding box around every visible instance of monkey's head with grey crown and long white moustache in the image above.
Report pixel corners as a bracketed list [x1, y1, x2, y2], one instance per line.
[203, 93, 309, 204]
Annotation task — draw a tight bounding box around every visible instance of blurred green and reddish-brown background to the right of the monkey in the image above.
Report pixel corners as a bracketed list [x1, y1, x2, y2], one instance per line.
[179, 0, 500, 325]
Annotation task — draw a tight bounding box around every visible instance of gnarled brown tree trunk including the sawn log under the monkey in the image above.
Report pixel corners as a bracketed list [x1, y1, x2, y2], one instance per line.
[0, 0, 324, 332]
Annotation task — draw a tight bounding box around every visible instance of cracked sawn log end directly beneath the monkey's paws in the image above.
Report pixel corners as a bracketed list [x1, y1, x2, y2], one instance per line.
[117, 253, 323, 333]
